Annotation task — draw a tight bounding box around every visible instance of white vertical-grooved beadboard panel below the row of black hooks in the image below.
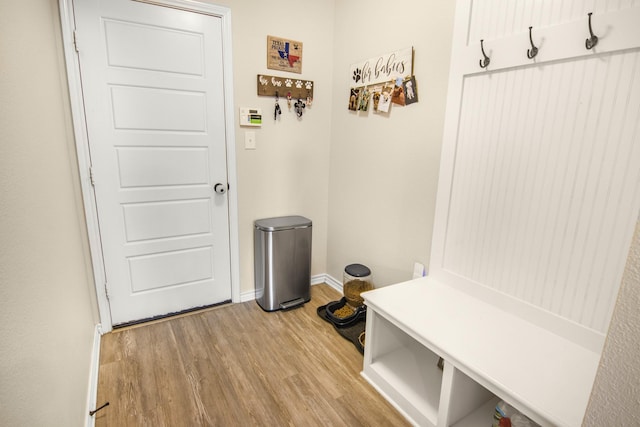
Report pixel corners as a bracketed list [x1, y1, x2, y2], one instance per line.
[443, 46, 640, 332]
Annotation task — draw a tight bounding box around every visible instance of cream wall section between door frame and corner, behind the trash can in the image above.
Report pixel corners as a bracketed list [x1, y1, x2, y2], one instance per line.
[210, 0, 334, 294]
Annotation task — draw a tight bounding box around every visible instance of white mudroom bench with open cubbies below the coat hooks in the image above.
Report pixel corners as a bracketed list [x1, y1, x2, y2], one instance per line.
[362, 277, 600, 427]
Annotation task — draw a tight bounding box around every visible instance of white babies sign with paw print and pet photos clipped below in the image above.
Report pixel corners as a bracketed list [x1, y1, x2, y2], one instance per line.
[349, 47, 418, 113]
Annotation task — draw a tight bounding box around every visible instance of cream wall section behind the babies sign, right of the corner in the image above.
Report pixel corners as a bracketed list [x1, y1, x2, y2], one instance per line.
[327, 0, 455, 286]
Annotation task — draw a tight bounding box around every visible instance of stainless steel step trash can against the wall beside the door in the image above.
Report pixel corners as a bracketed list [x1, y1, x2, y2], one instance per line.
[253, 216, 312, 311]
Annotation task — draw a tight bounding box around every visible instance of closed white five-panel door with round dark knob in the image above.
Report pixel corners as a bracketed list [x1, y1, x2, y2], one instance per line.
[74, 0, 231, 325]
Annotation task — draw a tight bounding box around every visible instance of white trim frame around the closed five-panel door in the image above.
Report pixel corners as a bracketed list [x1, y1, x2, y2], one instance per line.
[58, 0, 240, 332]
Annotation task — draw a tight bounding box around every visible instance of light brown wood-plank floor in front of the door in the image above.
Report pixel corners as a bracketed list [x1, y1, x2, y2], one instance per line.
[95, 284, 408, 427]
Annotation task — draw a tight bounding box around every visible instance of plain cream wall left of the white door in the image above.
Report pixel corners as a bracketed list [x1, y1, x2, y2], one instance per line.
[0, 0, 97, 426]
